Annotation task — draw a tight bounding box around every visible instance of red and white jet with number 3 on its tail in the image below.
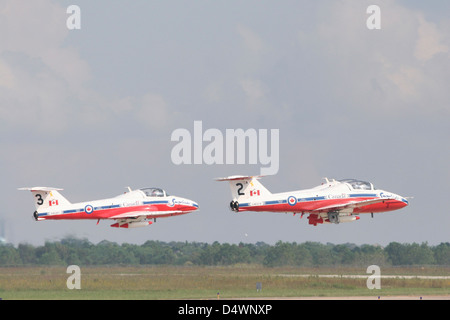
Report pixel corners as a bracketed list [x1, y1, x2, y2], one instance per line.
[19, 187, 198, 228]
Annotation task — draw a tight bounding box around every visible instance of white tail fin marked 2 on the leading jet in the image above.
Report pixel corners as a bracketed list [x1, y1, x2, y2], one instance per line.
[216, 176, 272, 202]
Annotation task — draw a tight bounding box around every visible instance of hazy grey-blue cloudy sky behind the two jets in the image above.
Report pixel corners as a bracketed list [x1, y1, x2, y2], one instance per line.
[0, 0, 450, 245]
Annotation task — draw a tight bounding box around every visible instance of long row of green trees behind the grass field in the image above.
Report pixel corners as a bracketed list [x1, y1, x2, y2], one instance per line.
[0, 237, 450, 267]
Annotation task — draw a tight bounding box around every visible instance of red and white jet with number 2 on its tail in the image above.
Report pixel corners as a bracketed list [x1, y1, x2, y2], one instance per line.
[216, 176, 408, 226]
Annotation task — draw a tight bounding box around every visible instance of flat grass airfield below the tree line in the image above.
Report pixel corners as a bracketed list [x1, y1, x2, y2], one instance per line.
[0, 265, 450, 300]
